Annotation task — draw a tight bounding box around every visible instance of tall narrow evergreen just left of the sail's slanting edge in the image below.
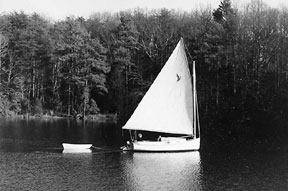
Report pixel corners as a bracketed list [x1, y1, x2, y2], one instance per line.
[110, 15, 139, 122]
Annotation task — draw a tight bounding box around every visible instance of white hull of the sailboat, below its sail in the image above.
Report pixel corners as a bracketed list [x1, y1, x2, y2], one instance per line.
[123, 138, 200, 152]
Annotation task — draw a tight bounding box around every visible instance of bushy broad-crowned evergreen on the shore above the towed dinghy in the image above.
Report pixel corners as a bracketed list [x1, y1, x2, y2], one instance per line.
[55, 18, 110, 115]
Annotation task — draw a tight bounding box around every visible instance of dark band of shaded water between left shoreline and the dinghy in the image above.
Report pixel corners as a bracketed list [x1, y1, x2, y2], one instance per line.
[0, 118, 121, 151]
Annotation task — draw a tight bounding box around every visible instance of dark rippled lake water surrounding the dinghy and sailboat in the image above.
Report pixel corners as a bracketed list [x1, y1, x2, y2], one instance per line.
[0, 119, 288, 191]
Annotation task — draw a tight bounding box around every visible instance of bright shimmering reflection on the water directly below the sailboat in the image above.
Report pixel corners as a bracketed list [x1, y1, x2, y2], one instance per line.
[124, 151, 201, 190]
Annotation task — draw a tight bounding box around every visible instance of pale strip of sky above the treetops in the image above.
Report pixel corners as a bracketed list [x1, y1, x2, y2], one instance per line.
[0, 0, 288, 20]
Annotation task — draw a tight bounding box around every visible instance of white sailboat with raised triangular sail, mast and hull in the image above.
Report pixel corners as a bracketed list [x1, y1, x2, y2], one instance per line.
[122, 38, 200, 152]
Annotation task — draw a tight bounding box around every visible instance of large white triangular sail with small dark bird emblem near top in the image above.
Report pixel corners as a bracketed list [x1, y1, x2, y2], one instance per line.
[123, 39, 194, 135]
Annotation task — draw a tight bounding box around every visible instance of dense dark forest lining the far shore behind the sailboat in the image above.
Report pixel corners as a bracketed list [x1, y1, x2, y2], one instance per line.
[0, 0, 288, 145]
